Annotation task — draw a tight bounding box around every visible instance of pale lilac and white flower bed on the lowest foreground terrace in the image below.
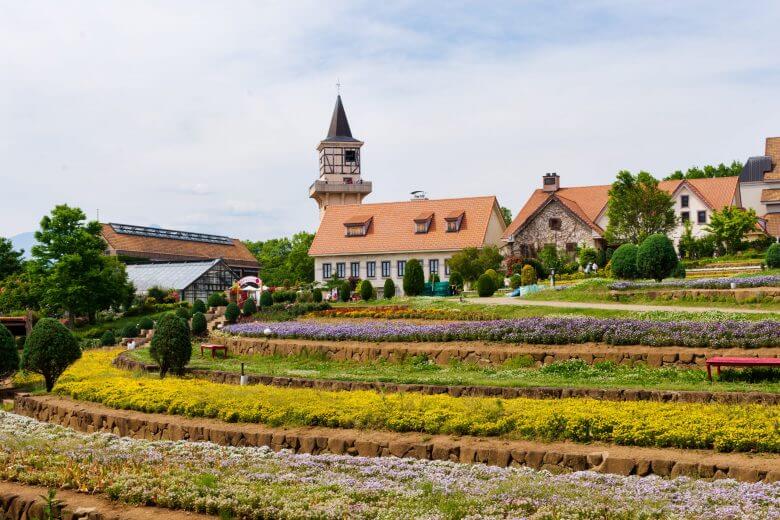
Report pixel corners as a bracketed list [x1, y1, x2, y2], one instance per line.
[0, 412, 780, 520]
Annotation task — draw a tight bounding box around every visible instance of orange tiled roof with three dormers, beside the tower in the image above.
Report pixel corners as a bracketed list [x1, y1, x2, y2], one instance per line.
[309, 196, 503, 256]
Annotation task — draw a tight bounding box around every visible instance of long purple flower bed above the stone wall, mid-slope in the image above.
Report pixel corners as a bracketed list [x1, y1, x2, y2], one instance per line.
[224, 318, 780, 348]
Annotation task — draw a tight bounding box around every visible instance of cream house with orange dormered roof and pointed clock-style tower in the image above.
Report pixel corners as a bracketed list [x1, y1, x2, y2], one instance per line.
[309, 96, 506, 294]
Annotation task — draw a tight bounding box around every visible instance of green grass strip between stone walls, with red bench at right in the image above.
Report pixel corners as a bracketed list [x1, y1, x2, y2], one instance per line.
[130, 345, 780, 392]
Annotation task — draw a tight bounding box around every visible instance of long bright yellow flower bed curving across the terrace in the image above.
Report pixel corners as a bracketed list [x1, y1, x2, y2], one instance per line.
[55, 350, 780, 452]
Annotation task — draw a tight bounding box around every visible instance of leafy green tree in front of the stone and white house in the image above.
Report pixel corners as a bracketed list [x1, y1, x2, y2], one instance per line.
[606, 170, 677, 244]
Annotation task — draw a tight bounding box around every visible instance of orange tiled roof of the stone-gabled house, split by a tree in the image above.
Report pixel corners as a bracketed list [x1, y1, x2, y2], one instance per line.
[504, 177, 739, 238]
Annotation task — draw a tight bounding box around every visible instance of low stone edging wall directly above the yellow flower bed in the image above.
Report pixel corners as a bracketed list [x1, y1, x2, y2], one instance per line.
[114, 352, 780, 405]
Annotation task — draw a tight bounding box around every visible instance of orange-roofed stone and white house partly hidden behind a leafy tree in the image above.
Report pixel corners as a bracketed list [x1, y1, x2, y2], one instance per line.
[502, 173, 742, 257]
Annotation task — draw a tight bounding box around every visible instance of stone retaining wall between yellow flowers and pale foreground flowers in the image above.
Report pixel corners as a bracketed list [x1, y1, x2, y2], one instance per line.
[14, 394, 780, 482]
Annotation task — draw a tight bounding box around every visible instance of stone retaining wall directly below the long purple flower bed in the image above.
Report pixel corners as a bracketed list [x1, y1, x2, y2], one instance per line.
[215, 334, 780, 367]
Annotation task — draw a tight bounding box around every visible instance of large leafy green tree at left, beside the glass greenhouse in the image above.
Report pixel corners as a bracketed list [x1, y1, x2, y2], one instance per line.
[32, 205, 132, 326]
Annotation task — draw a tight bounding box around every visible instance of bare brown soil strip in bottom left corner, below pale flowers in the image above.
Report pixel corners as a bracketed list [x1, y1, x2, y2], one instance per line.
[0, 481, 215, 520]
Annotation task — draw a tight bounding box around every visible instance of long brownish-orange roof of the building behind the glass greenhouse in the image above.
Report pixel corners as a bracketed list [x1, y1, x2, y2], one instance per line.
[102, 224, 257, 267]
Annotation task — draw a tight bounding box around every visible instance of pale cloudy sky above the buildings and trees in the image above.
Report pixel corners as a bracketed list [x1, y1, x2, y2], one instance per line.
[0, 0, 780, 240]
